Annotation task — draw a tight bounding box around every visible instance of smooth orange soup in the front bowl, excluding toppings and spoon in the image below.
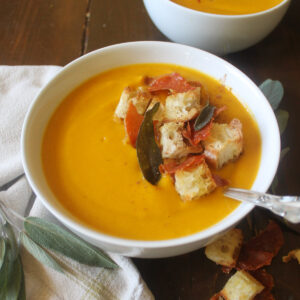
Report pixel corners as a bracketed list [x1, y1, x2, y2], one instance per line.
[42, 64, 261, 240]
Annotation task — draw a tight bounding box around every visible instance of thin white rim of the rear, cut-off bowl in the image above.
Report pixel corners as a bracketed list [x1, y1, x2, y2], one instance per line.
[159, 0, 291, 19]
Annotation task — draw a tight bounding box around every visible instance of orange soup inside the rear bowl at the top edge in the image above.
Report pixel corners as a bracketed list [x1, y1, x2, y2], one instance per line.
[171, 0, 283, 15]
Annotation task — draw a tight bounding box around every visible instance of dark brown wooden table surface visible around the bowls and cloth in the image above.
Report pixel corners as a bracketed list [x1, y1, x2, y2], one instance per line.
[0, 0, 300, 300]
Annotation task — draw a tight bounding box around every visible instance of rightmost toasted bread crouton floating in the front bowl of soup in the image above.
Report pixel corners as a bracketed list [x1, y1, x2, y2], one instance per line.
[203, 119, 243, 169]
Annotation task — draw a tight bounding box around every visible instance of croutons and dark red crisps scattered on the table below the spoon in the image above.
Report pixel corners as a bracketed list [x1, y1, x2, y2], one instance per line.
[205, 221, 284, 300]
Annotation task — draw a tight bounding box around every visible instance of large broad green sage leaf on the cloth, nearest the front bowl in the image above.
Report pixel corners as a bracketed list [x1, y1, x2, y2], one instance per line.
[24, 217, 117, 269]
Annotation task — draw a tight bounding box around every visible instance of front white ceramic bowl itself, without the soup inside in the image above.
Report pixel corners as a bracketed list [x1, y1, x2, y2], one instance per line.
[22, 42, 280, 258]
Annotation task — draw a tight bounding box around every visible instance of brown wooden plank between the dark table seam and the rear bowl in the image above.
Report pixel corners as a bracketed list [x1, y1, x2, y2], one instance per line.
[86, 0, 167, 52]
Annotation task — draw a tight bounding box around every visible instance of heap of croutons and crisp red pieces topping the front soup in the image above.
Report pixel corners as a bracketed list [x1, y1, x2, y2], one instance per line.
[115, 73, 243, 200]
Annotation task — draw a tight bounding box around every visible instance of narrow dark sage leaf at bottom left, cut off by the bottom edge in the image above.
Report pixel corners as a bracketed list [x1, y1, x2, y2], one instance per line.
[5, 257, 22, 300]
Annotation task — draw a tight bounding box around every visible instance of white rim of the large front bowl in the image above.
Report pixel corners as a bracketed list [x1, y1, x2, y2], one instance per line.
[21, 41, 280, 249]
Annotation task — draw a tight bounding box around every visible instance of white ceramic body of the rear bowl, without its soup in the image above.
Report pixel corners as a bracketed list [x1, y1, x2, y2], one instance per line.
[144, 0, 290, 55]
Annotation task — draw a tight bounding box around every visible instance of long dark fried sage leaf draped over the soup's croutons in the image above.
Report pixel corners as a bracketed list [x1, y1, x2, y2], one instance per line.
[136, 102, 163, 185]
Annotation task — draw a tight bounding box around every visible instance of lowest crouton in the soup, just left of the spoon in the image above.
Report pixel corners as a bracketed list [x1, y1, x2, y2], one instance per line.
[175, 162, 217, 200]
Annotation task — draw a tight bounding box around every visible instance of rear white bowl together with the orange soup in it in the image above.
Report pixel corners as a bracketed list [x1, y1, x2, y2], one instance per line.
[144, 0, 290, 55]
